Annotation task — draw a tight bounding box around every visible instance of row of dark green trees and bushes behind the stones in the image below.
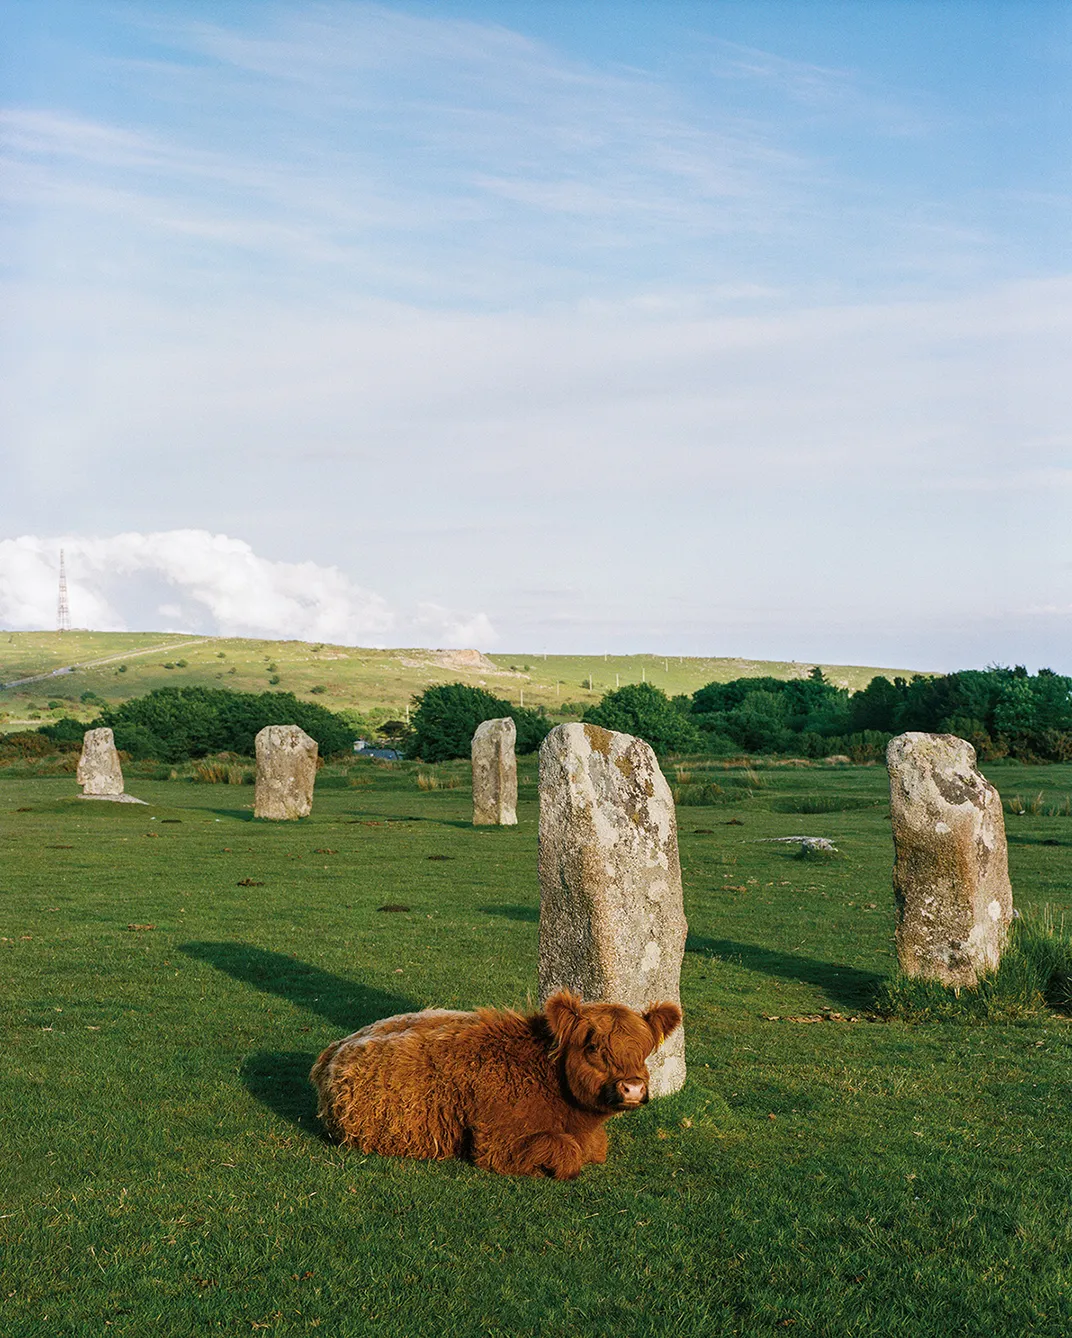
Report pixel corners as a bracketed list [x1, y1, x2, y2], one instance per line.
[33, 665, 1072, 763]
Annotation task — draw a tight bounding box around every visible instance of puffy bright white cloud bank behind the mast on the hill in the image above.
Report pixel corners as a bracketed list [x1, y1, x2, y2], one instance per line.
[0, 530, 497, 648]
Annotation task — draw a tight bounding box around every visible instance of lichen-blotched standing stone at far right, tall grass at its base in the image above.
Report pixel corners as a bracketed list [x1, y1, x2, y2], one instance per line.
[886, 733, 1013, 986]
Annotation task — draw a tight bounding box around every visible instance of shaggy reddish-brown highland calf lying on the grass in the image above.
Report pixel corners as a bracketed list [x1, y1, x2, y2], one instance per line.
[309, 990, 681, 1180]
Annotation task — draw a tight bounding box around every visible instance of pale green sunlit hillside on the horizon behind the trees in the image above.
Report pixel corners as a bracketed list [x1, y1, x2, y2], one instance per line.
[0, 632, 914, 729]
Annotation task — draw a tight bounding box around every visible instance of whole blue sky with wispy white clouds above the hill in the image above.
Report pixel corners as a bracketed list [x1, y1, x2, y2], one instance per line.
[0, 0, 1072, 672]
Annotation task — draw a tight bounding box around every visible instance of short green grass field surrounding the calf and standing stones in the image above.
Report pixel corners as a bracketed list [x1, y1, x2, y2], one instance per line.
[0, 759, 1072, 1338]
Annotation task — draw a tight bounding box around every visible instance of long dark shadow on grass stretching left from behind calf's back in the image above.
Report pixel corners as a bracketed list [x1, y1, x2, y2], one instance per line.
[179, 943, 420, 1033]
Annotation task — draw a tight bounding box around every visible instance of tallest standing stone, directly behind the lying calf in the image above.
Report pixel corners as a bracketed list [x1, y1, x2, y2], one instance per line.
[539, 724, 688, 1096]
